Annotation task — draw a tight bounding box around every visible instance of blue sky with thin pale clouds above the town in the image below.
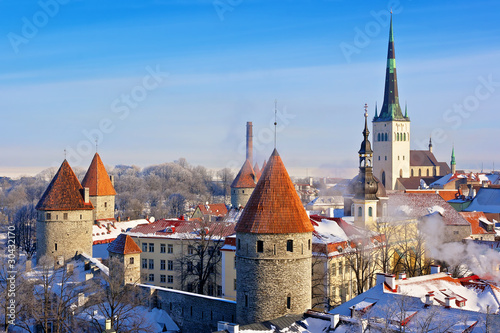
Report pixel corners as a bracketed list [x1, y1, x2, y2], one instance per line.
[0, 0, 500, 176]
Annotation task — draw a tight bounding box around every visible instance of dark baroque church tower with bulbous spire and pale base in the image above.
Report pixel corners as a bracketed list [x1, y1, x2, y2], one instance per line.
[352, 104, 379, 228]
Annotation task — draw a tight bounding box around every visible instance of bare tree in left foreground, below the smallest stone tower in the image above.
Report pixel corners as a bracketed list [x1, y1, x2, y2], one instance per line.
[84, 258, 154, 333]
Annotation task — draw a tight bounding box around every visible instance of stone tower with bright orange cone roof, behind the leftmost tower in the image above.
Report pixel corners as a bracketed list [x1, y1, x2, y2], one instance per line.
[82, 153, 116, 220]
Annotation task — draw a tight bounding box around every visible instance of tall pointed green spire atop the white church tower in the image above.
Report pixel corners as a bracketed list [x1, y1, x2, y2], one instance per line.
[377, 14, 408, 121]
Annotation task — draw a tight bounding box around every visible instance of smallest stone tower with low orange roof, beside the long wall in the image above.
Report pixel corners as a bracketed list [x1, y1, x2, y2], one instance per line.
[108, 234, 142, 285]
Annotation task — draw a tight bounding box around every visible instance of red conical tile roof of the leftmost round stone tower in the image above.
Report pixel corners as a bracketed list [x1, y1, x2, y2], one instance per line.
[36, 160, 94, 210]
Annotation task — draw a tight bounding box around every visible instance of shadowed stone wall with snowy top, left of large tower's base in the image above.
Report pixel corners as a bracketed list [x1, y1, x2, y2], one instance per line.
[145, 285, 236, 333]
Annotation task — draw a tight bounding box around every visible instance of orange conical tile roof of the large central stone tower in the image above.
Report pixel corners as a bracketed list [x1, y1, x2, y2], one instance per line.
[235, 149, 314, 234]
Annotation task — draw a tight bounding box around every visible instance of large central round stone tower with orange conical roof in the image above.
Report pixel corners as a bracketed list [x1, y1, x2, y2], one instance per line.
[235, 149, 314, 324]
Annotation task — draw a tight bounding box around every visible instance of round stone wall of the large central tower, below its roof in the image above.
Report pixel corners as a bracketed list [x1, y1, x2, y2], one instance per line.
[236, 233, 312, 324]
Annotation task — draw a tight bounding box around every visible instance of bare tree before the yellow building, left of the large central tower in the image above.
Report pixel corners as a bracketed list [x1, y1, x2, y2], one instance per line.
[177, 218, 225, 296]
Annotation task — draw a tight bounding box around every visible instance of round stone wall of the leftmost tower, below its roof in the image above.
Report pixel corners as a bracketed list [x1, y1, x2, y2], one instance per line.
[36, 210, 93, 260]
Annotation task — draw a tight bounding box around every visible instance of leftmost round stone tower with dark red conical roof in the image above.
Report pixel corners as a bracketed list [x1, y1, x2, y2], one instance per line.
[36, 160, 94, 262]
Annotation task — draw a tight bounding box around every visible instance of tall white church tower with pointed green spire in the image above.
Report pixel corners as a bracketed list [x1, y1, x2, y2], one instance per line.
[373, 14, 410, 190]
